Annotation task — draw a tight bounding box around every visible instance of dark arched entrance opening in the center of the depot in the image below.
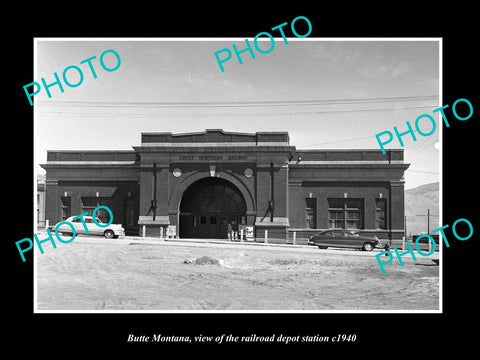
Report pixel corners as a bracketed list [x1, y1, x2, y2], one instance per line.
[179, 177, 246, 239]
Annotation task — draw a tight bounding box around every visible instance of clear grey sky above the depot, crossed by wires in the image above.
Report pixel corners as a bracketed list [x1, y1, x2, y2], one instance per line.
[32, 37, 442, 189]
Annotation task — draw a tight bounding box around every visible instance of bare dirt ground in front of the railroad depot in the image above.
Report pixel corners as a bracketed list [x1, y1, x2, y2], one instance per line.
[37, 239, 439, 311]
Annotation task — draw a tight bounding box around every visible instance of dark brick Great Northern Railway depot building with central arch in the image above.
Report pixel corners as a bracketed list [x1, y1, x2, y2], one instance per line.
[41, 129, 409, 242]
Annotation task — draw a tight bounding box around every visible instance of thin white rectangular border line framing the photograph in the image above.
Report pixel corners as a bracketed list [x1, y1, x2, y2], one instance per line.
[32, 37, 443, 314]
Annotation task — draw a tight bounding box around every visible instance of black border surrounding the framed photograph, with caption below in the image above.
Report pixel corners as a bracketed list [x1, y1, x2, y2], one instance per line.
[6, 2, 480, 356]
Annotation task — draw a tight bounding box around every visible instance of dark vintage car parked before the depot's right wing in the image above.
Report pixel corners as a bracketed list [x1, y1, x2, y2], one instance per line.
[308, 229, 379, 251]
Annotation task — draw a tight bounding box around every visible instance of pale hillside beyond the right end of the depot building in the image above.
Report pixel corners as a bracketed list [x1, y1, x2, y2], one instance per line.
[405, 182, 440, 235]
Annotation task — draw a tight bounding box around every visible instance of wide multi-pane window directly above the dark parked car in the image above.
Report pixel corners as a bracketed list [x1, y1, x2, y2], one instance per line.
[328, 199, 363, 229]
